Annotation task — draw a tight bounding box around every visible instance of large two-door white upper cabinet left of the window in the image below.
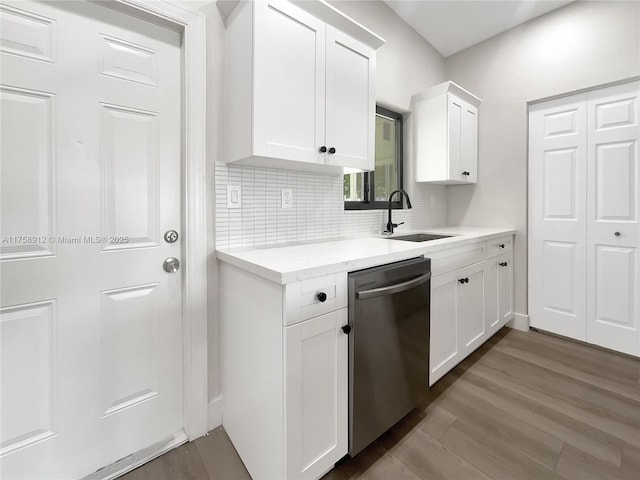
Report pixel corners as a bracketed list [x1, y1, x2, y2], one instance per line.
[224, 0, 384, 171]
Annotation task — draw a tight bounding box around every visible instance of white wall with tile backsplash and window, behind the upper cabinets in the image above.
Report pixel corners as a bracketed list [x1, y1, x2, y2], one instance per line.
[202, 1, 446, 420]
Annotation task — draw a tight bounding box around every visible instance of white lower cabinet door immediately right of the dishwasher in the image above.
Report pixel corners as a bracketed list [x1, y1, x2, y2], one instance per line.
[429, 271, 460, 386]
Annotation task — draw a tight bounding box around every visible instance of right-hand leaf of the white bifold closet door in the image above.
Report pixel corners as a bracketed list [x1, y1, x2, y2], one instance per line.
[587, 82, 640, 355]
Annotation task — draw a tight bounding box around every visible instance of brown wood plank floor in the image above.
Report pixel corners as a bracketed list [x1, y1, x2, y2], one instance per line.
[122, 328, 640, 480]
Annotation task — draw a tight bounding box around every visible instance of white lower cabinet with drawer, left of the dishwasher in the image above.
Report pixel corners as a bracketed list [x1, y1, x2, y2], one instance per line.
[220, 262, 348, 479]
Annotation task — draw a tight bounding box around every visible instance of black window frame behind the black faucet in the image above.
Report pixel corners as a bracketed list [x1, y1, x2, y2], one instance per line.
[344, 105, 404, 210]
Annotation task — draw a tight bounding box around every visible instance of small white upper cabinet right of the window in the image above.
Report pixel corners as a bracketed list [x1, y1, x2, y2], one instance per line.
[412, 81, 481, 185]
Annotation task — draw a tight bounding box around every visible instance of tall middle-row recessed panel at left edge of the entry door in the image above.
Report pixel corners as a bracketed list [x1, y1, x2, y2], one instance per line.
[0, 86, 56, 259]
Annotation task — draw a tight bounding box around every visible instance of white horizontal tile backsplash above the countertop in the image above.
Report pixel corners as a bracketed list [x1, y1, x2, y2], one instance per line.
[215, 162, 447, 248]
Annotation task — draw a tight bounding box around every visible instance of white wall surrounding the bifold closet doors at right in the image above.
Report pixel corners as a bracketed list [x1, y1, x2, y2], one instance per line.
[446, 1, 640, 322]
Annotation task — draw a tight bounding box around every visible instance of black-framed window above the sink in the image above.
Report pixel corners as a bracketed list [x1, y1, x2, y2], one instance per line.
[344, 106, 402, 210]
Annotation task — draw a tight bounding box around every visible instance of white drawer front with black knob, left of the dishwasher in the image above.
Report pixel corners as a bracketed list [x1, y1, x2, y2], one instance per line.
[283, 272, 347, 325]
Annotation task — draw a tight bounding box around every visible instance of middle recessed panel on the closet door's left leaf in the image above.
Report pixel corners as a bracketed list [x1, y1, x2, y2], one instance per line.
[543, 148, 578, 220]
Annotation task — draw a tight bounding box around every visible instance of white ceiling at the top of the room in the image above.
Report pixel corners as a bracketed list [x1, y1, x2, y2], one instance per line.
[384, 0, 572, 57]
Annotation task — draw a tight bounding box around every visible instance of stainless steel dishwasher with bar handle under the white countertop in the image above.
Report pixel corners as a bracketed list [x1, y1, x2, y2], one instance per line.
[346, 257, 431, 457]
